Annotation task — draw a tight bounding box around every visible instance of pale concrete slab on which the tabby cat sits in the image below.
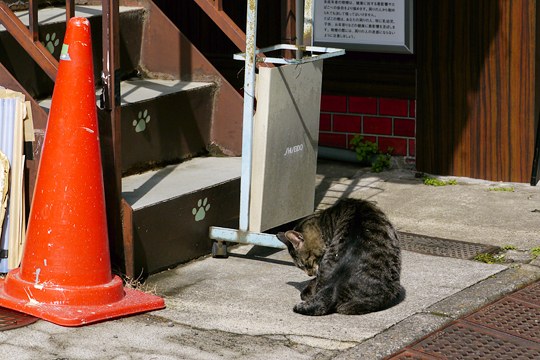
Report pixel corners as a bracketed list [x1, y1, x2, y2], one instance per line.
[144, 246, 506, 350]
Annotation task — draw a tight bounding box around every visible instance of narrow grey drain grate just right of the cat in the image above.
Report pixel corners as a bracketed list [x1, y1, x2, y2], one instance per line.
[399, 232, 499, 260]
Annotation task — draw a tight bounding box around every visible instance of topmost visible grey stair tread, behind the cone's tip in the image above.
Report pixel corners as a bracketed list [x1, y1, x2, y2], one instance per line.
[0, 5, 143, 31]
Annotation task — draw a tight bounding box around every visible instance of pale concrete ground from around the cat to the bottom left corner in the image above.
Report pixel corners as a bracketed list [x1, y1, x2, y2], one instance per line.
[0, 246, 506, 359]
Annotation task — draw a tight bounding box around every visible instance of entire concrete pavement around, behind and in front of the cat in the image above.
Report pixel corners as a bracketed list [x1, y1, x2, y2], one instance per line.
[0, 160, 540, 359]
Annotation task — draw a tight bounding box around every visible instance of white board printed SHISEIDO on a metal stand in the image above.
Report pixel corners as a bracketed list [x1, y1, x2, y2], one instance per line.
[249, 61, 323, 232]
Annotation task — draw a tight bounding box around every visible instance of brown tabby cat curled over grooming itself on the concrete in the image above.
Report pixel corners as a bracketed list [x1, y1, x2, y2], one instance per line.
[277, 199, 405, 315]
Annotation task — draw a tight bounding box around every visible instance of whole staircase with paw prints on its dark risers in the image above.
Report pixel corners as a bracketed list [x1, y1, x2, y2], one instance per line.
[0, 2, 242, 275]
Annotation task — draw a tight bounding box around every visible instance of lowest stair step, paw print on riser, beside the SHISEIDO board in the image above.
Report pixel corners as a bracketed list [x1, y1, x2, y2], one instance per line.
[122, 157, 241, 275]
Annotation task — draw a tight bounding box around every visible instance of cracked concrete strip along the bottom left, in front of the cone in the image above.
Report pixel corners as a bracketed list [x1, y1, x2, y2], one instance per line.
[0, 312, 332, 360]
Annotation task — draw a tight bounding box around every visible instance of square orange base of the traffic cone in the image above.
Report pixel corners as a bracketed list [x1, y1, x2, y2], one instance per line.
[0, 272, 165, 327]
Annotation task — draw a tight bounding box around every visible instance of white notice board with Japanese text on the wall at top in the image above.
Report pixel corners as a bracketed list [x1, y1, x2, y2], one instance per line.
[313, 0, 413, 53]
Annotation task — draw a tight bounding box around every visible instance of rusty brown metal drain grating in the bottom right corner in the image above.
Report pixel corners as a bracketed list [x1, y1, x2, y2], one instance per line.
[386, 282, 540, 360]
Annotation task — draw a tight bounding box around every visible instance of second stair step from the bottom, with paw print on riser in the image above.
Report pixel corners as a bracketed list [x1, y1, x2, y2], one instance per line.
[39, 78, 215, 174]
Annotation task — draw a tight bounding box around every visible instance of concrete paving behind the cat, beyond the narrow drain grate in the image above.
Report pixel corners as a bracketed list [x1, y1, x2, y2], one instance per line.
[317, 163, 540, 250]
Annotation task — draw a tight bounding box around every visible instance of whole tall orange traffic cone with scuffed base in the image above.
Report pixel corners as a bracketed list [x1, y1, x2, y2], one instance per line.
[0, 18, 165, 326]
